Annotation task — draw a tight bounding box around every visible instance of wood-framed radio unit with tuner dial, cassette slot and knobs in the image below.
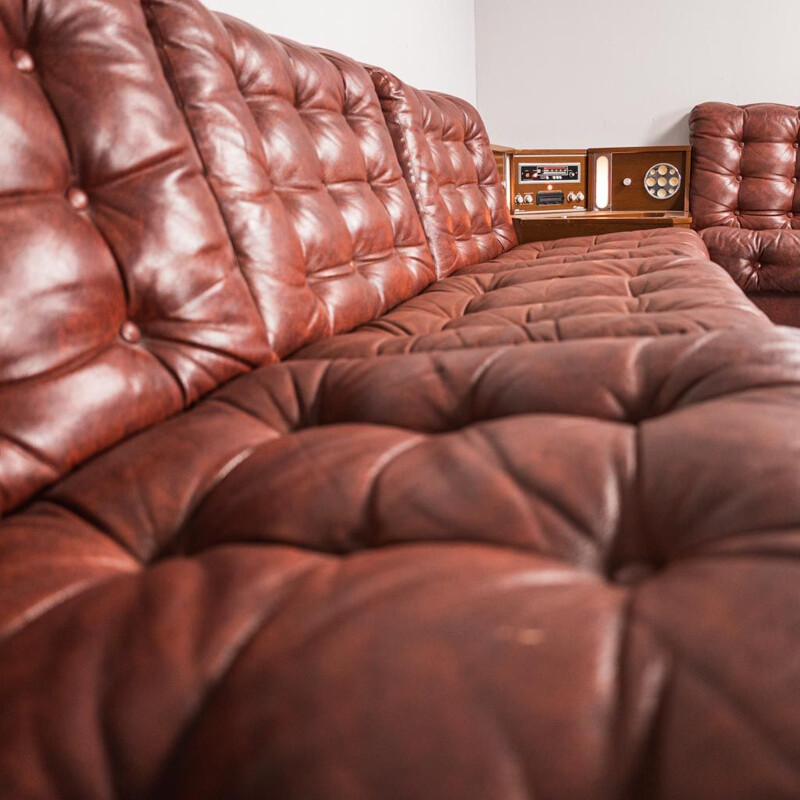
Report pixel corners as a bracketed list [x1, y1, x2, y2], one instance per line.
[510, 150, 588, 212]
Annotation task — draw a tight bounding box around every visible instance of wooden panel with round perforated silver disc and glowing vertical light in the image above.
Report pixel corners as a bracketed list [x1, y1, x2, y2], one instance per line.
[588, 147, 691, 212]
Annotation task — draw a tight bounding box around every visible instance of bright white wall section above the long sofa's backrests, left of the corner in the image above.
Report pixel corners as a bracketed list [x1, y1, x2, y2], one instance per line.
[211, 0, 476, 103]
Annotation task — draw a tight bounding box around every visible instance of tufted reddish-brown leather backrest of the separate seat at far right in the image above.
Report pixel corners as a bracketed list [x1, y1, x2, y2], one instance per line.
[690, 103, 800, 230]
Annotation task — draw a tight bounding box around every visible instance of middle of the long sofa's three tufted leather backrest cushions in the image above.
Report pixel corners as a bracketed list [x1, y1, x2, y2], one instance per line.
[146, 0, 434, 355]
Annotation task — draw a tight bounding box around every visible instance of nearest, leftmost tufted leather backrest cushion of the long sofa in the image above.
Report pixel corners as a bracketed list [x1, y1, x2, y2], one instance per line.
[0, 0, 269, 513]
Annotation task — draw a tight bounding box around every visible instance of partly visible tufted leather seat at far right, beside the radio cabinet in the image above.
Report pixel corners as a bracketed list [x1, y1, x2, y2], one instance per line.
[690, 103, 800, 327]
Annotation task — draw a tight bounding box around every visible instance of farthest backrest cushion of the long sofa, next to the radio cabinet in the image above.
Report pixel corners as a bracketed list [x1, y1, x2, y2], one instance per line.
[368, 72, 517, 278]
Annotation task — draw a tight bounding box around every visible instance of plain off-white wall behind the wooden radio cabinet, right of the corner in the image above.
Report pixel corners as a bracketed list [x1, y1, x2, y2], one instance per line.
[475, 0, 800, 147]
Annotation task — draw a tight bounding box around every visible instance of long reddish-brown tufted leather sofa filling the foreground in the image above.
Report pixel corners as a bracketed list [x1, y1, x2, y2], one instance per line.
[0, 0, 800, 800]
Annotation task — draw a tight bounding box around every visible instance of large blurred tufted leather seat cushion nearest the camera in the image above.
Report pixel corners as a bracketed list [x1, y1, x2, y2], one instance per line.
[0, 330, 800, 800]
